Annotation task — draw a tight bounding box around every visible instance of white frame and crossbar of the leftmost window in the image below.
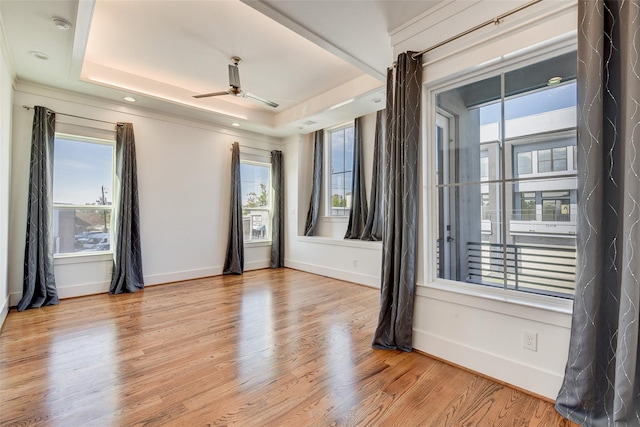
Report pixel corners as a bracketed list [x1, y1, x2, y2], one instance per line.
[52, 132, 117, 259]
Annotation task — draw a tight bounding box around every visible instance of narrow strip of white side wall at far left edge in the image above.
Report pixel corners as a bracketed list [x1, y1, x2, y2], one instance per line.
[0, 22, 13, 327]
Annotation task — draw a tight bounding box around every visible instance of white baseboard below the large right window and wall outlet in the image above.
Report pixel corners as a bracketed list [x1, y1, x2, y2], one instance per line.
[413, 329, 563, 400]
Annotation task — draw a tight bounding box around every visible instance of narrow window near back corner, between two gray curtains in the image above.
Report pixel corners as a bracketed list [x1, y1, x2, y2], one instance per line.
[240, 160, 271, 242]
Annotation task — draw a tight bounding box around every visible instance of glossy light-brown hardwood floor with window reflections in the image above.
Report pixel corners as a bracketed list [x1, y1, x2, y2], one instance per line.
[0, 269, 573, 427]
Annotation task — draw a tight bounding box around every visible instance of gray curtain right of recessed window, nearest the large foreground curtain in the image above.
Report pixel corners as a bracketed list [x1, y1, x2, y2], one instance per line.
[361, 110, 386, 240]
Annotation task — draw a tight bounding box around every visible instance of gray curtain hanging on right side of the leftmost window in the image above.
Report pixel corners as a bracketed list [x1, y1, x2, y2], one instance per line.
[109, 123, 144, 294]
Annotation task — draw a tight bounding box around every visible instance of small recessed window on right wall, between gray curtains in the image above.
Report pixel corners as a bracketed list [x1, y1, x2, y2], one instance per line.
[327, 125, 354, 216]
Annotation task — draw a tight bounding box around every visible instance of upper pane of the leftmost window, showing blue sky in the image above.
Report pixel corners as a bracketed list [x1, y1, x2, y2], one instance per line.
[53, 137, 113, 205]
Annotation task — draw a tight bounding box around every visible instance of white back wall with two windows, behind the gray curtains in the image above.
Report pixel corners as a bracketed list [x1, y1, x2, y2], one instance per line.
[3, 86, 280, 305]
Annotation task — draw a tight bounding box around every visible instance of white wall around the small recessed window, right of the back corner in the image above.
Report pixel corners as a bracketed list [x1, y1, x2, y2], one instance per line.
[285, 113, 382, 287]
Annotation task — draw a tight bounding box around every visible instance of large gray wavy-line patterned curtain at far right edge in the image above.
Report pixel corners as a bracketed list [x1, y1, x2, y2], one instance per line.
[556, 0, 640, 426]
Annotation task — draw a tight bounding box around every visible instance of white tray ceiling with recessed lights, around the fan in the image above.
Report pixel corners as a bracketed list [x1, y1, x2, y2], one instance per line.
[0, 0, 441, 136]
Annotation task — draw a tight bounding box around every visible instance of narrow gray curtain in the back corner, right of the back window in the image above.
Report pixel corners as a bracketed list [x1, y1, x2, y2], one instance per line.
[271, 150, 285, 268]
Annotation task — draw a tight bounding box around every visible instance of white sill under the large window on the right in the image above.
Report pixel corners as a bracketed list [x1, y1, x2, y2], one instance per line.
[416, 280, 573, 328]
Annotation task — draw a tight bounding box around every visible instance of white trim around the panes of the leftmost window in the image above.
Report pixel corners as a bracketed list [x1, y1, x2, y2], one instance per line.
[52, 132, 118, 265]
